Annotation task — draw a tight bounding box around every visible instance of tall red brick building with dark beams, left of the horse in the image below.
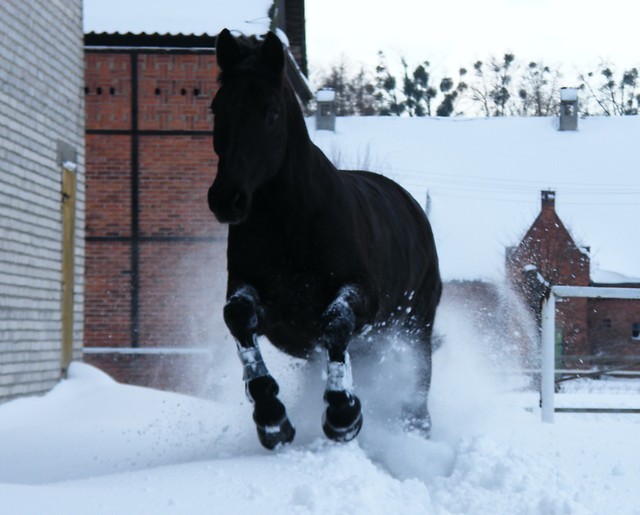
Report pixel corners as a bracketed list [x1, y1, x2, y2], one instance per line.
[85, 29, 309, 392]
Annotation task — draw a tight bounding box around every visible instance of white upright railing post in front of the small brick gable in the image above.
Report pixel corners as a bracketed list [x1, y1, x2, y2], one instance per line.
[540, 290, 556, 422]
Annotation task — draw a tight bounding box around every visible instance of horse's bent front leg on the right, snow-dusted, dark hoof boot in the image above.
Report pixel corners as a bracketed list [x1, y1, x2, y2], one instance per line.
[321, 285, 365, 442]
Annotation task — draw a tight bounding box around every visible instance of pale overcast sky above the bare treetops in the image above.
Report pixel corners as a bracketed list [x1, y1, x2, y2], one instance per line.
[306, 0, 640, 79]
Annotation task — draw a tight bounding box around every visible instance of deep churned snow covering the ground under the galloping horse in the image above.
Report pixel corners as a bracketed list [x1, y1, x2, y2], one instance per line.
[0, 298, 640, 515]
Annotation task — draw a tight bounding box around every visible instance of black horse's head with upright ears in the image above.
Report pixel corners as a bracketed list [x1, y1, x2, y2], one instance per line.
[208, 29, 287, 224]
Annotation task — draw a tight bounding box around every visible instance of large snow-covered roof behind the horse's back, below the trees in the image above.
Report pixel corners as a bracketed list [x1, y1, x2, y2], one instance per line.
[308, 116, 640, 282]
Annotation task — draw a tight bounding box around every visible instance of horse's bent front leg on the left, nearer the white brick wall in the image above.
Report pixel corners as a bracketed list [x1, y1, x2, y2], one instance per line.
[224, 286, 295, 449]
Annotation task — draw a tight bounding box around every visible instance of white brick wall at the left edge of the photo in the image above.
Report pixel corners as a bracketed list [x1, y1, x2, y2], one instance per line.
[0, 0, 84, 402]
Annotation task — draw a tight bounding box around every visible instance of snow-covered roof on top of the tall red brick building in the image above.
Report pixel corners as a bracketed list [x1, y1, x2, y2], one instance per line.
[83, 0, 273, 36]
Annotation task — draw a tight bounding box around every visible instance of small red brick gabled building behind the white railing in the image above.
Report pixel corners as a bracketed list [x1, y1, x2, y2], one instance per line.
[506, 191, 640, 368]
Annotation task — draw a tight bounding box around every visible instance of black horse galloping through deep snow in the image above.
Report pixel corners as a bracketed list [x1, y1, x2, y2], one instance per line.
[208, 29, 441, 449]
